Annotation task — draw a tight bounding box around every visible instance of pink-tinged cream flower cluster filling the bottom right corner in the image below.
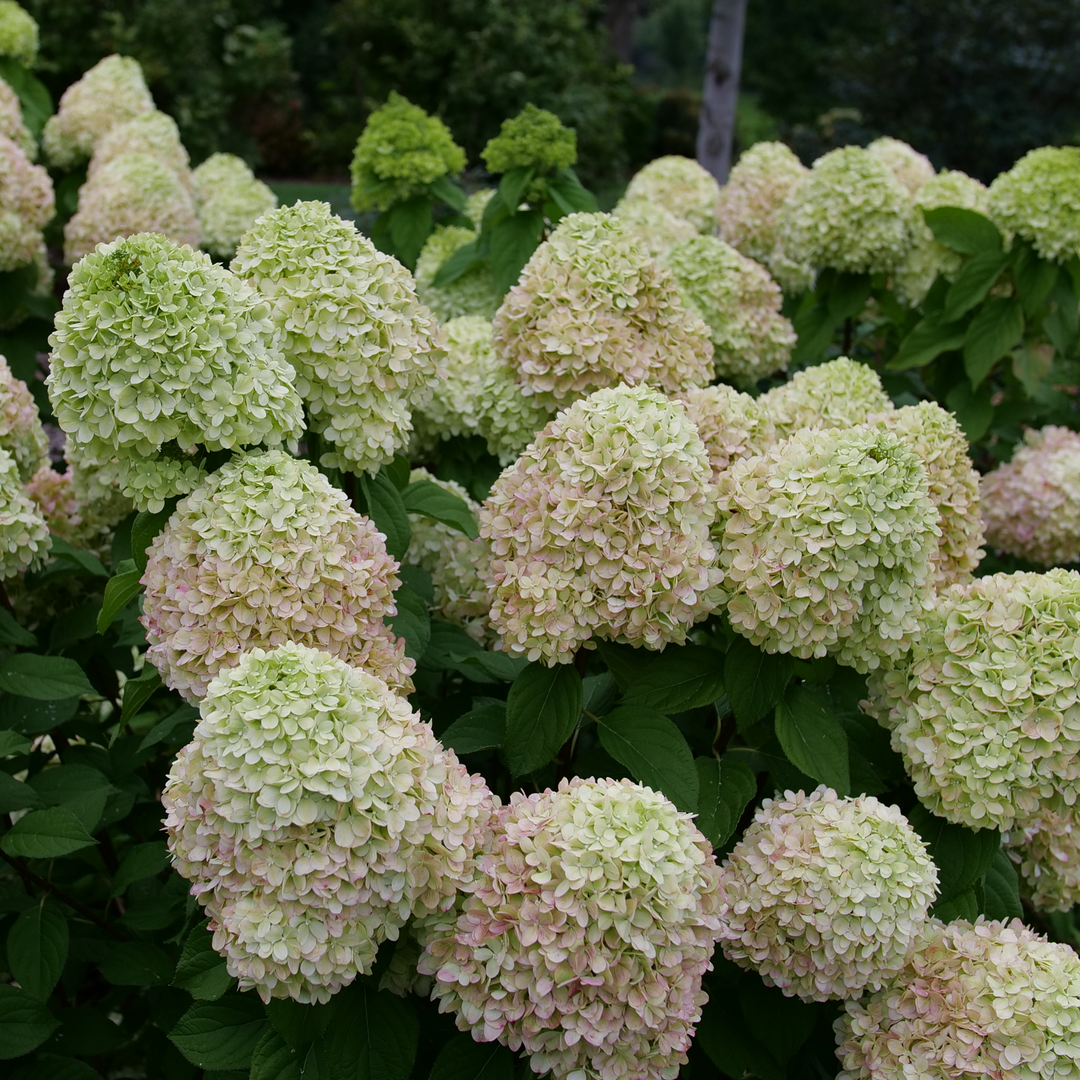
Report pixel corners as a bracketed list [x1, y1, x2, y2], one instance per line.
[834, 919, 1080, 1080]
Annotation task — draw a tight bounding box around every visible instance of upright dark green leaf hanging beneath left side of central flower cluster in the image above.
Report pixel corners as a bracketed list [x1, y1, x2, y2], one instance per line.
[503, 662, 582, 777]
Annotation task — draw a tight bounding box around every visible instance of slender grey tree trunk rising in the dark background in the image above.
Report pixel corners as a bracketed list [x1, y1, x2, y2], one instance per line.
[698, 0, 746, 184]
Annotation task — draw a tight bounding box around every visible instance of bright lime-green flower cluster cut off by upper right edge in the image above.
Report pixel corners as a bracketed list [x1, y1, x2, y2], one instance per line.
[988, 146, 1080, 262]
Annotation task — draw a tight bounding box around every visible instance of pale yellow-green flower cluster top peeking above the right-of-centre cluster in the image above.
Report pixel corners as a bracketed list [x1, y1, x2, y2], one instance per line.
[758, 356, 893, 438]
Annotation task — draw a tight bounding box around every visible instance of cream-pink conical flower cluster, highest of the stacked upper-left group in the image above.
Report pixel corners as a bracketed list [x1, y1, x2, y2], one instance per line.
[41, 55, 153, 168]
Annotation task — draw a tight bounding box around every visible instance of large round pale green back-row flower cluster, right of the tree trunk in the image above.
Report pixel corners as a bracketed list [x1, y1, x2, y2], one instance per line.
[780, 146, 913, 273]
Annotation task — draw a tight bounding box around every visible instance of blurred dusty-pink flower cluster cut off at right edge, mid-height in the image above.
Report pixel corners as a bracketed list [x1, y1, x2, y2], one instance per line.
[982, 427, 1080, 566]
